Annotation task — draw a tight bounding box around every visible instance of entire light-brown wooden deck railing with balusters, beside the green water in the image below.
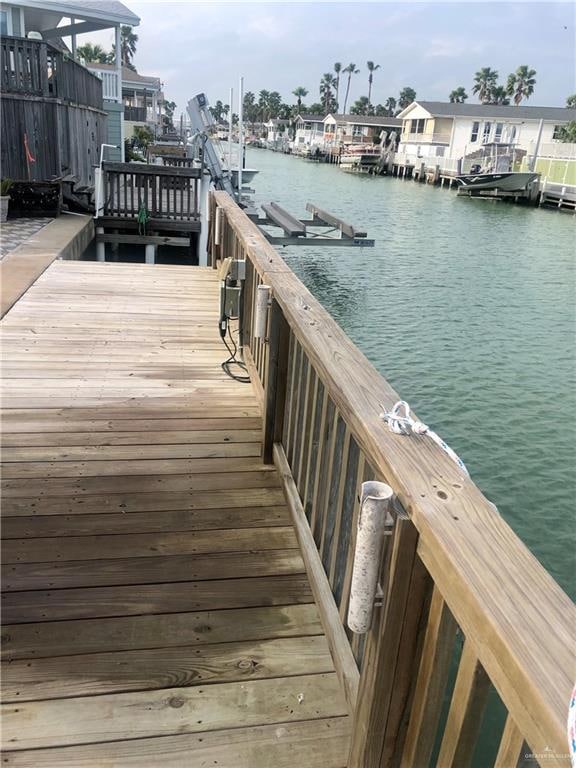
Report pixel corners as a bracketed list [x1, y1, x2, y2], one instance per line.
[209, 192, 576, 768]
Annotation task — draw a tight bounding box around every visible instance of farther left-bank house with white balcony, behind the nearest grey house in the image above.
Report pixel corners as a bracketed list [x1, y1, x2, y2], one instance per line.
[86, 63, 164, 139]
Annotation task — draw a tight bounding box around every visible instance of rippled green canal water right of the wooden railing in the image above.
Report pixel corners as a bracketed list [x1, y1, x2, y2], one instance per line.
[247, 150, 576, 598]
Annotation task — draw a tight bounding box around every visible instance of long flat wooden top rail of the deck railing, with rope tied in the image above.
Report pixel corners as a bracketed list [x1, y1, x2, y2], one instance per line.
[214, 192, 576, 752]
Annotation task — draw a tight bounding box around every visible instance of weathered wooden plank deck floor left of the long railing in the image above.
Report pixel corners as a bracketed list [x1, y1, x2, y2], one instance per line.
[2, 262, 349, 768]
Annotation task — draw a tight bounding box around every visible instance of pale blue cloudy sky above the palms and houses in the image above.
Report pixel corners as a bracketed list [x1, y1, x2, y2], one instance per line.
[88, 0, 576, 114]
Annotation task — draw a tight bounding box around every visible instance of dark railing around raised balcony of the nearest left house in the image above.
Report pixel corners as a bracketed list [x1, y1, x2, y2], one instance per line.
[0, 37, 102, 109]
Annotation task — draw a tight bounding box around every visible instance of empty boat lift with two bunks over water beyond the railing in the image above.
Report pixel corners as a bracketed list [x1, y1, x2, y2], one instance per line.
[249, 203, 374, 248]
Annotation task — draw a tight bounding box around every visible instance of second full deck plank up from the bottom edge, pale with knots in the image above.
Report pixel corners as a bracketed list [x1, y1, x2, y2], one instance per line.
[2, 673, 346, 750]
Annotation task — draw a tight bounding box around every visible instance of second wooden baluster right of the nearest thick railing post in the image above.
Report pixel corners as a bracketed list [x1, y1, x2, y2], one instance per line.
[438, 640, 490, 768]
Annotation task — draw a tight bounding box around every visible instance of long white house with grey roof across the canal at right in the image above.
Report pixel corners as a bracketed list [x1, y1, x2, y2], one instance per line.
[398, 101, 576, 170]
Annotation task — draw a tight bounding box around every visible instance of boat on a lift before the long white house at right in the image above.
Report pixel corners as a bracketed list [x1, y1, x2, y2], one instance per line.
[456, 143, 539, 192]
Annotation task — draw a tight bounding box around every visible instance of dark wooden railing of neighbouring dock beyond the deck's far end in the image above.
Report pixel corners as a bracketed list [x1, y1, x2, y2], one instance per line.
[103, 163, 200, 224]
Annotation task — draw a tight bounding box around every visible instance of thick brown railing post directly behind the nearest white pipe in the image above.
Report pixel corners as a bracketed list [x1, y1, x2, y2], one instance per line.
[348, 511, 432, 768]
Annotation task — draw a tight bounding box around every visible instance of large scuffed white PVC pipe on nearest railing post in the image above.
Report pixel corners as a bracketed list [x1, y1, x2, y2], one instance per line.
[348, 481, 394, 634]
